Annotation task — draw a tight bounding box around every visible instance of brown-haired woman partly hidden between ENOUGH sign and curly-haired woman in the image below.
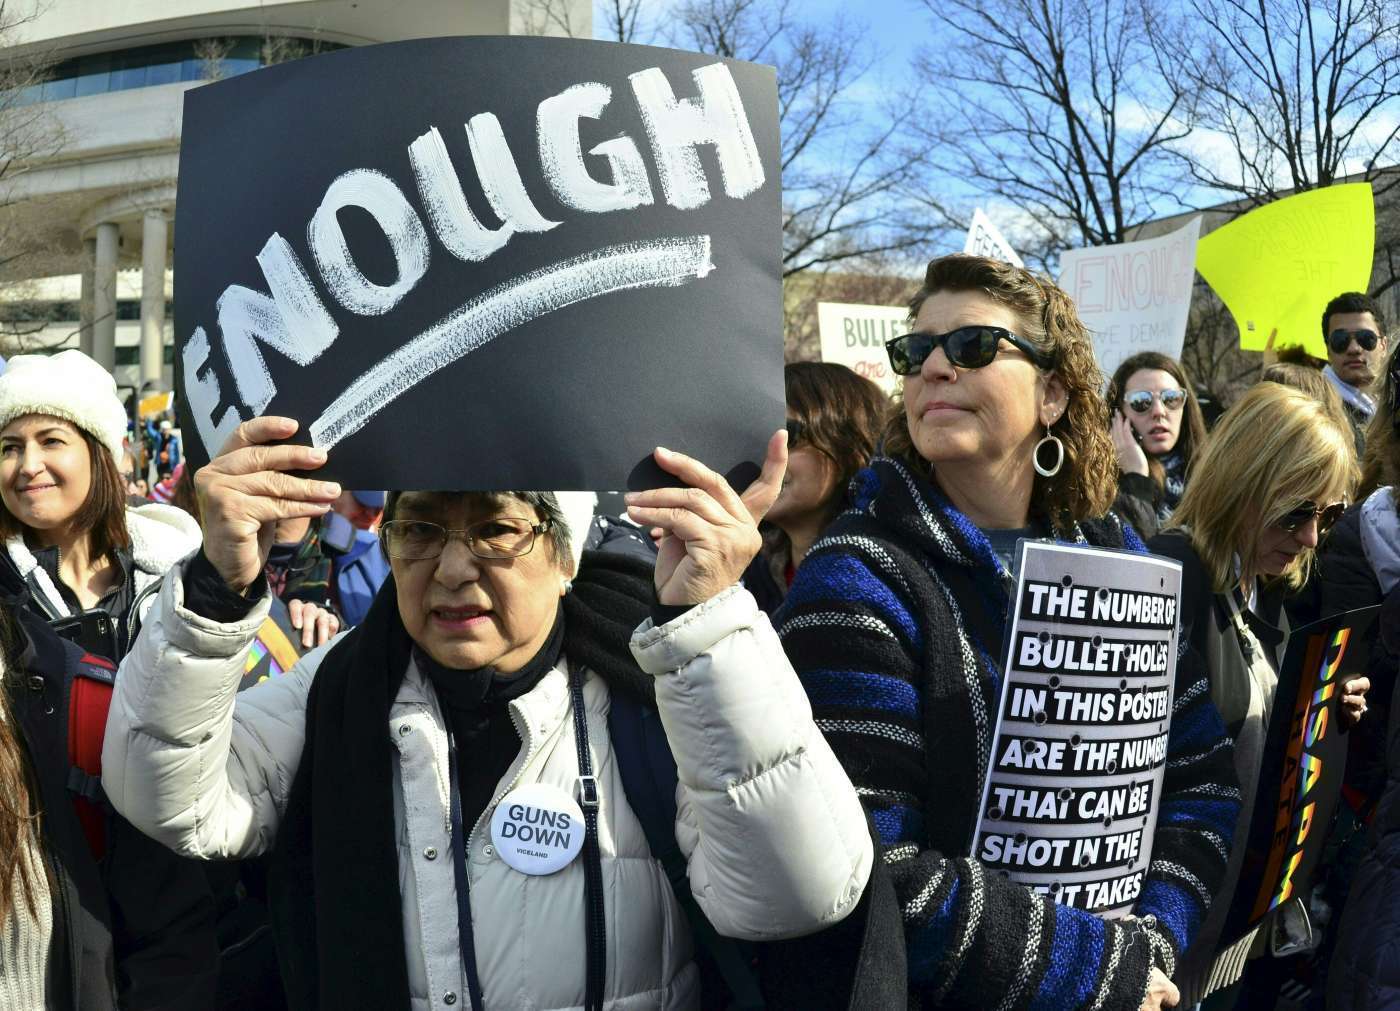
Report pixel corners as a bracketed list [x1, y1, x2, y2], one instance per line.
[743, 361, 889, 615]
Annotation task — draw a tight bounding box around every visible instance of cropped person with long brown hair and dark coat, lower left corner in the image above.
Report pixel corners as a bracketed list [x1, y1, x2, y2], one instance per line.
[0, 559, 218, 1011]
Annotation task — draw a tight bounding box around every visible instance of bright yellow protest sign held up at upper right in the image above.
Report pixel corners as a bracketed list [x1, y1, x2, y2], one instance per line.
[1196, 182, 1376, 358]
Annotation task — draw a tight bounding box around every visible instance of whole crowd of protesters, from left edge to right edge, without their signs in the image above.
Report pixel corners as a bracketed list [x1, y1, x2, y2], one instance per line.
[0, 255, 1400, 1011]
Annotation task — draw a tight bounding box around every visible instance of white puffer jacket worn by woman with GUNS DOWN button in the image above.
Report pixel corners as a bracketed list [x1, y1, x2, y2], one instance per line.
[102, 565, 872, 1011]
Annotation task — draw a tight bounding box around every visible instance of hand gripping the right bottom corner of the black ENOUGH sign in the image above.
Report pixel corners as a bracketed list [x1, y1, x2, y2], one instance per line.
[626, 431, 787, 606]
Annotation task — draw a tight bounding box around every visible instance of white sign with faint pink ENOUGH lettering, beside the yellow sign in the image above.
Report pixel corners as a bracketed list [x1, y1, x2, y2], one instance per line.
[1060, 217, 1201, 379]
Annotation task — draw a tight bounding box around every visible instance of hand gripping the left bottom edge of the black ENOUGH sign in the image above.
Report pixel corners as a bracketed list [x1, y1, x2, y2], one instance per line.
[195, 417, 340, 592]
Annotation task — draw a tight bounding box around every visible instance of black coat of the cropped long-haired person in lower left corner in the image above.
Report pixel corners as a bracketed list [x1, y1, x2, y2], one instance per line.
[0, 560, 218, 1011]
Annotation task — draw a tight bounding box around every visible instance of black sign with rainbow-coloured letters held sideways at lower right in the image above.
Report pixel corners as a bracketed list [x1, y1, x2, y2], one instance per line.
[1222, 608, 1380, 941]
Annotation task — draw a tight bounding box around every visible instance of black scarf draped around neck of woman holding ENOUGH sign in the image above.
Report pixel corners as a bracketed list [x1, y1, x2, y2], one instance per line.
[270, 552, 655, 1011]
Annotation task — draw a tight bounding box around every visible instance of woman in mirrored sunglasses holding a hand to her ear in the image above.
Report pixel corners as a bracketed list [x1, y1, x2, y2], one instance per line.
[1107, 351, 1205, 538]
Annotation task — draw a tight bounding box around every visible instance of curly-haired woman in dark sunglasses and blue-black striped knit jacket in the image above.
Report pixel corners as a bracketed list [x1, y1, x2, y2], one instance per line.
[774, 255, 1233, 1011]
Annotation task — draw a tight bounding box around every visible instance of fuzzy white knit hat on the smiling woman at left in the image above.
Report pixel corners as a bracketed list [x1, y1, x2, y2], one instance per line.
[0, 350, 126, 462]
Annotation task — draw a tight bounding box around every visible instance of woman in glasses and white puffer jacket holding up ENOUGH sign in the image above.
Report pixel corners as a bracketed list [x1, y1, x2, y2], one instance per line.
[104, 417, 872, 1011]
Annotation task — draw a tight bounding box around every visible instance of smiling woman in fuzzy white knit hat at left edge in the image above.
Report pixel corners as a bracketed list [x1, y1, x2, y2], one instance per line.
[0, 350, 333, 661]
